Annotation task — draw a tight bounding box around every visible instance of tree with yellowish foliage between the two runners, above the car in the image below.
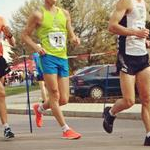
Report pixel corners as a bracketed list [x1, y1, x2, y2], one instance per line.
[59, 0, 116, 70]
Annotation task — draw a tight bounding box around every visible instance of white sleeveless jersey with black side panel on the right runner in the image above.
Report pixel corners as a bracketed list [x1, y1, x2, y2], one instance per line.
[119, 0, 147, 56]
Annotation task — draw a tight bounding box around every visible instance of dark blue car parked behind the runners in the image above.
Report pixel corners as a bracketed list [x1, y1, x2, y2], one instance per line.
[70, 65, 121, 99]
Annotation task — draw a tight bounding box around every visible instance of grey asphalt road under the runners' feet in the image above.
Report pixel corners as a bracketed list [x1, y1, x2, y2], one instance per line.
[0, 115, 149, 150]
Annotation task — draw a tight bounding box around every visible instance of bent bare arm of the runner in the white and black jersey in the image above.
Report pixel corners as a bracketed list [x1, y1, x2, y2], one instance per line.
[108, 0, 149, 38]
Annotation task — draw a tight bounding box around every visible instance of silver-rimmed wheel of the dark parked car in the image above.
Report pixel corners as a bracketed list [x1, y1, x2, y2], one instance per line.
[90, 86, 103, 99]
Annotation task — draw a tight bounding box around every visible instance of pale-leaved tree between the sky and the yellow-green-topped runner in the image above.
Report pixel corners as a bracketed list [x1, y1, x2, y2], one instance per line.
[10, 0, 42, 63]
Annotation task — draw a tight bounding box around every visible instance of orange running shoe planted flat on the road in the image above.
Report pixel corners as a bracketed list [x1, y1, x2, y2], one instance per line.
[62, 129, 81, 140]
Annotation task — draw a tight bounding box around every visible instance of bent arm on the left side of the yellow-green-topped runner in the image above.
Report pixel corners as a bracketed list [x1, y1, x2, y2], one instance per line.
[22, 11, 45, 55]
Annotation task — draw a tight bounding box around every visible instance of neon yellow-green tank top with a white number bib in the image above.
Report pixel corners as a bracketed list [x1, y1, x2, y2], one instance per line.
[36, 7, 67, 59]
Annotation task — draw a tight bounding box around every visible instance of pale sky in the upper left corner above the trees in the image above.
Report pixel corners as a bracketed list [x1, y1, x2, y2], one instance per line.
[0, 0, 29, 24]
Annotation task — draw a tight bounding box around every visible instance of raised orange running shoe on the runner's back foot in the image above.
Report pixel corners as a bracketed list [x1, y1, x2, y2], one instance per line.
[33, 104, 43, 128]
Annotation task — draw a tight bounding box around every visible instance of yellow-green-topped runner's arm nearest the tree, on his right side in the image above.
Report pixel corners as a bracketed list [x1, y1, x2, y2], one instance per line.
[63, 10, 80, 45]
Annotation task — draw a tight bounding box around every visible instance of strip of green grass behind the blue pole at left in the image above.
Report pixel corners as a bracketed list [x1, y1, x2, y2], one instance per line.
[5, 84, 40, 96]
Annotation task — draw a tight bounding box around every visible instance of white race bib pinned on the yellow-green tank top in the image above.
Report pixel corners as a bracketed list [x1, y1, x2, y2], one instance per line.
[48, 32, 66, 48]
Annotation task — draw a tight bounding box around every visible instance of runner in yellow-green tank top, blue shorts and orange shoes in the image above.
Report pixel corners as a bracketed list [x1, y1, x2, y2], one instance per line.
[22, 0, 81, 139]
